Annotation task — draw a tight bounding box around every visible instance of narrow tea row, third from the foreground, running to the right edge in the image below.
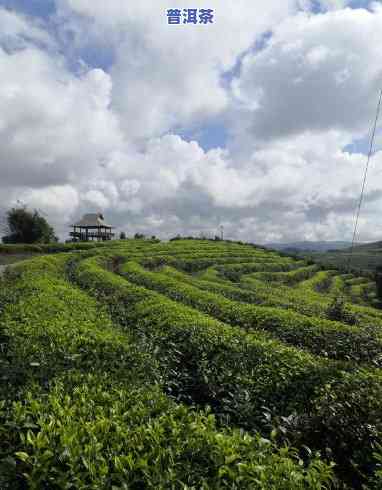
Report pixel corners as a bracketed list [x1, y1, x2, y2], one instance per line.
[121, 262, 382, 366]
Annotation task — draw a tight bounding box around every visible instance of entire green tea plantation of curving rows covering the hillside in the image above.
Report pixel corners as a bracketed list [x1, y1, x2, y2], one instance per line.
[0, 240, 382, 490]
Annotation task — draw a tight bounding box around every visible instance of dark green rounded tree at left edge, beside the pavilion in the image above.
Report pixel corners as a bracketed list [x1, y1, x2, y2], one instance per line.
[2, 206, 58, 243]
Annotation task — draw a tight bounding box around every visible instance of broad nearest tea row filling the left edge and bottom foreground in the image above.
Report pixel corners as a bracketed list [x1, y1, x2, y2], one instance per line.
[0, 256, 332, 490]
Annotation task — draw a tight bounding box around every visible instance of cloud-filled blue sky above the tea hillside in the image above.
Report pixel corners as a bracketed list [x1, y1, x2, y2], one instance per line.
[0, 0, 382, 243]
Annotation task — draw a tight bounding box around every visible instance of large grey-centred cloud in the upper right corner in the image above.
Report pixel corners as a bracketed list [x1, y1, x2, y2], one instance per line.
[232, 8, 382, 144]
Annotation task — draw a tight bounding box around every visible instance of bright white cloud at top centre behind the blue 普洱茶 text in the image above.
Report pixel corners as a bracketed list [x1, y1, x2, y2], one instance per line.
[56, 0, 299, 138]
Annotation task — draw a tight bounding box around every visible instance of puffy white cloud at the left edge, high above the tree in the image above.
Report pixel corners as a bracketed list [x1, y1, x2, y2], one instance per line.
[0, 37, 123, 187]
